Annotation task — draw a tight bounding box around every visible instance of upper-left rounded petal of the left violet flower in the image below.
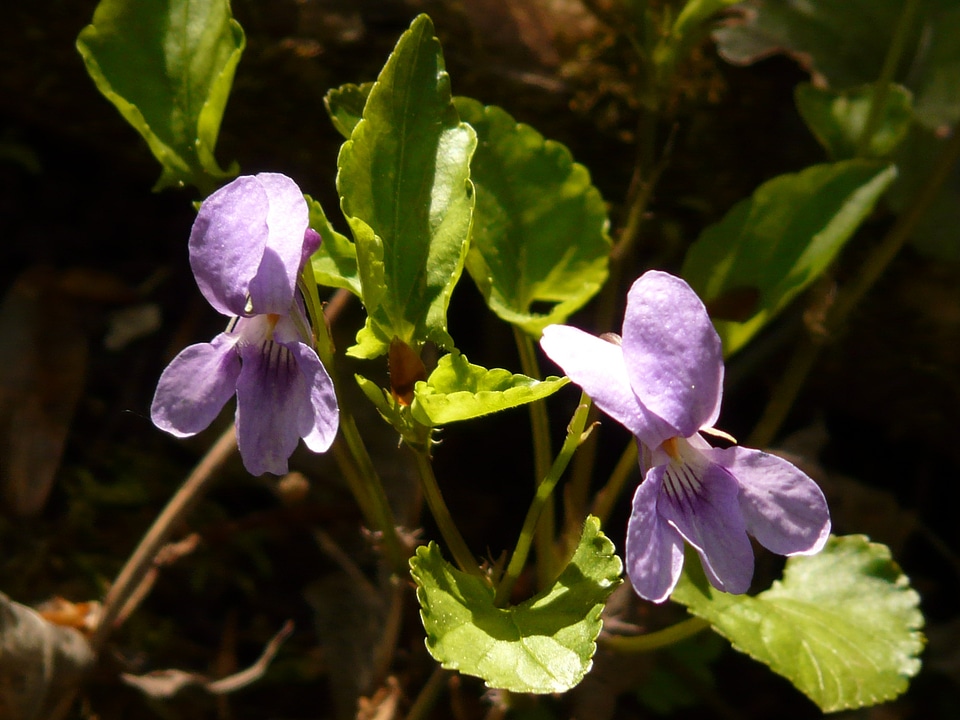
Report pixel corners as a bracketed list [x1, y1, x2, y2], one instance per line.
[189, 175, 270, 316]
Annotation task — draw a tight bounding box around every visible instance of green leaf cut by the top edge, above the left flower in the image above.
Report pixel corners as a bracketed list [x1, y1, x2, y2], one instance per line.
[77, 0, 245, 192]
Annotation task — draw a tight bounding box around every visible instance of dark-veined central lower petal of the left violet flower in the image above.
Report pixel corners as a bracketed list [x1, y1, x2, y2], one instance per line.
[237, 341, 310, 475]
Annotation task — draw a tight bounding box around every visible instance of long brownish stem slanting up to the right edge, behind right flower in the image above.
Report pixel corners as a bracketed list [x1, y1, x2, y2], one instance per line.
[747, 125, 960, 447]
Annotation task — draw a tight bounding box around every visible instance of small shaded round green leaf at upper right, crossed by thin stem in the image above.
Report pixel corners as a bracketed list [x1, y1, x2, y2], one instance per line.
[794, 83, 913, 160]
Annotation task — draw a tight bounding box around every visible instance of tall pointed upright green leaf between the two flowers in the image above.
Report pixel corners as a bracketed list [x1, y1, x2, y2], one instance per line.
[337, 15, 476, 357]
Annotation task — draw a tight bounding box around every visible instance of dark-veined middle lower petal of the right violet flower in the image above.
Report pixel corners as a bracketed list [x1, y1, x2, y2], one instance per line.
[660, 463, 753, 594]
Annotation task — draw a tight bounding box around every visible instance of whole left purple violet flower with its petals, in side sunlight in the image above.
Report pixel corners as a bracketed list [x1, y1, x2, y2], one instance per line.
[150, 173, 340, 475]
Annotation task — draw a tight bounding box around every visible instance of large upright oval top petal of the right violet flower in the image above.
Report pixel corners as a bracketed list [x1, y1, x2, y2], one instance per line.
[623, 271, 723, 436]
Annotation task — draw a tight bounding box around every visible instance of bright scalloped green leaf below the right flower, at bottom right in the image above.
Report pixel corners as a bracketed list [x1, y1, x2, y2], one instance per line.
[671, 535, 924, 712]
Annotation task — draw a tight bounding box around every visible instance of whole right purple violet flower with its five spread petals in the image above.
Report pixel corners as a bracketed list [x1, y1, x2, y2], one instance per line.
[540, 271, 830, 602]
